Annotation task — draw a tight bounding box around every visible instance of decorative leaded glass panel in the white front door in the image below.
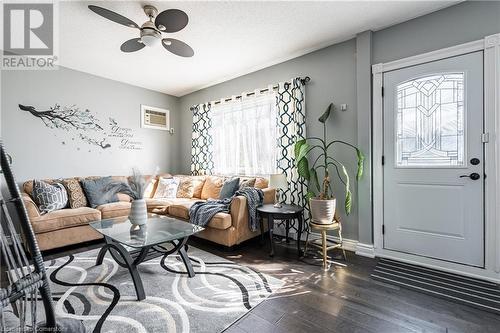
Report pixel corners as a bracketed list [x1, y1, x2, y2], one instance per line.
[396, 73, 464, 167]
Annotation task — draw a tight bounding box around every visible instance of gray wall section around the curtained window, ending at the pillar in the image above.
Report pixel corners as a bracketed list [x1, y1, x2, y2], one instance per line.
[179, 39, 358, 239]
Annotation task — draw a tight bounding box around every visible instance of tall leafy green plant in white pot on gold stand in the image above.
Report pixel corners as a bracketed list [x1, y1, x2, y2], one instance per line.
[294, 103, 364, 224]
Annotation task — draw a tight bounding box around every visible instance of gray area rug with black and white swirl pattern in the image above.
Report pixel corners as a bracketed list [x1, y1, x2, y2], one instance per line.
[21, 247, 283, 332]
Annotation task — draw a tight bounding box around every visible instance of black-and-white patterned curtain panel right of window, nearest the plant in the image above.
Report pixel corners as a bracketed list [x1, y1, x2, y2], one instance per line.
[277, 78, 307, 208]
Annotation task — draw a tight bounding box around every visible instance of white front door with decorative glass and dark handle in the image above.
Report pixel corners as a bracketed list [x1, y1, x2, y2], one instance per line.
[383, 51, 485, 267]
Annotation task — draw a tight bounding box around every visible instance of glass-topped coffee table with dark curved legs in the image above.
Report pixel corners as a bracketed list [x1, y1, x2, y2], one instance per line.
[89, 214, 204, 301]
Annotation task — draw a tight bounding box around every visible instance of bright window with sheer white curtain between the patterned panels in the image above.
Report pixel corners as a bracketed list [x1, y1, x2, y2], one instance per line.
[212, 93, 278, 176]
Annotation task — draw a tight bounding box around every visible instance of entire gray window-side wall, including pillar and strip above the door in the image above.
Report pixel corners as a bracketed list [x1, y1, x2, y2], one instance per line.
[178, 1, 500, 243]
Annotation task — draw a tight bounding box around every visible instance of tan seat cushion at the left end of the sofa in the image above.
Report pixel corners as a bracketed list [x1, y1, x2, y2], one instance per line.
[31, 207, 101, 233]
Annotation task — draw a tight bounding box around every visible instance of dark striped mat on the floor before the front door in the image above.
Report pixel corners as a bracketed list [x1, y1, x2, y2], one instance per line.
[371, 259, 500, 314]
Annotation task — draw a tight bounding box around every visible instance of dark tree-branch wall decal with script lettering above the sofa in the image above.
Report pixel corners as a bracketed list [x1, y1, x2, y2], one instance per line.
[19, 104, 143, 152]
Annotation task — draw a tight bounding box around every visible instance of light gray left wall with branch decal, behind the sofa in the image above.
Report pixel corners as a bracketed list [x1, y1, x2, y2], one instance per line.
[0, 67, 180, 181]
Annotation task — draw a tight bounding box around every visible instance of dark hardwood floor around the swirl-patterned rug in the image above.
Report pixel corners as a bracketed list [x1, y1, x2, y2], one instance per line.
[44, 239, 500, 333]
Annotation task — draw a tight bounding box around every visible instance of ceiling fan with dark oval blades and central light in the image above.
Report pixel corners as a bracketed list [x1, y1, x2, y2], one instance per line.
[89, 5, 194, 57]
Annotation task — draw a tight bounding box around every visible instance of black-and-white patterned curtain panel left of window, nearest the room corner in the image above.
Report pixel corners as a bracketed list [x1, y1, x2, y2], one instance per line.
[191, 103, 214, 176]
